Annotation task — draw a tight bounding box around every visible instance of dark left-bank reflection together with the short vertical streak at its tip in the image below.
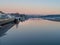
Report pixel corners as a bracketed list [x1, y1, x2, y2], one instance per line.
[0, 21, 19, 37]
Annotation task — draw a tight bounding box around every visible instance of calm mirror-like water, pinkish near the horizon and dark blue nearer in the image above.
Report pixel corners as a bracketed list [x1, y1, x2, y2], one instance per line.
[0, 19, 60, 45]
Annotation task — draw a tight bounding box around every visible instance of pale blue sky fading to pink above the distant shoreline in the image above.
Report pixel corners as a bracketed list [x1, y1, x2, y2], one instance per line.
[0, 0, 60, 14]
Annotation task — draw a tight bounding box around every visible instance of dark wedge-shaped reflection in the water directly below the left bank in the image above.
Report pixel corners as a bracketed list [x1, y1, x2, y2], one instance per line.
[0, 22, 14, 37]
